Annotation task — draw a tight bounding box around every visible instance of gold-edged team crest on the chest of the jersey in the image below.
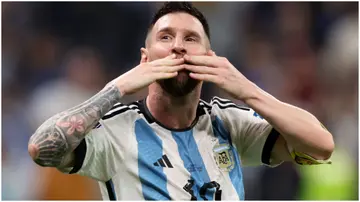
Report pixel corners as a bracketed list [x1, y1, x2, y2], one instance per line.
[213, 144, 234, 172]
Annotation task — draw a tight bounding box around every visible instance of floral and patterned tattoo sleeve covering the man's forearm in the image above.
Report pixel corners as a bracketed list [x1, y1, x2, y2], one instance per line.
[29, 85, 121, 167]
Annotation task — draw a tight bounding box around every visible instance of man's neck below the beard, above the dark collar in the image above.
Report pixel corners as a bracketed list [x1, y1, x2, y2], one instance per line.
[146, 83, 201, 129]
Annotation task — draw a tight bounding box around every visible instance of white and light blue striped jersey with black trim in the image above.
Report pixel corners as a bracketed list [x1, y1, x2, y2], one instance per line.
[61, 97, 279, 200]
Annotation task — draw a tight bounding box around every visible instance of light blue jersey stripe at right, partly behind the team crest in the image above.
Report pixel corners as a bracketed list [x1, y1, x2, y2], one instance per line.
[212, 117, 245, 200]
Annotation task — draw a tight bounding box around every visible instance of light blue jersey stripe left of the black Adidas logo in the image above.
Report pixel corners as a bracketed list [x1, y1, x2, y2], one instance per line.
[134, 119, 171, 200]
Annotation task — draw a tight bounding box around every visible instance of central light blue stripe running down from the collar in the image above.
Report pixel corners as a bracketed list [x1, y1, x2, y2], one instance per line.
[172, 130, 214, 201]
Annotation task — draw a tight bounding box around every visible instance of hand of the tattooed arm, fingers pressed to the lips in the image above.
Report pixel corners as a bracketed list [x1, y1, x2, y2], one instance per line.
[112, 54, 184, 96]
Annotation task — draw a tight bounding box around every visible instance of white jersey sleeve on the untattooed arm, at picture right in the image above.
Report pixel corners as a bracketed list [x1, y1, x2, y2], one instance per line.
[211, 97, 279, 166]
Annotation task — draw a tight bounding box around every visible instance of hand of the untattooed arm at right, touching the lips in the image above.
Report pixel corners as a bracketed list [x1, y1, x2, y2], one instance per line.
[184, 51, 255, 100]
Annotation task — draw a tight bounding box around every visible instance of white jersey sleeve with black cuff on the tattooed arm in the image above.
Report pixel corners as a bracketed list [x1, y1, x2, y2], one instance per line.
[59, 102, 138, 181]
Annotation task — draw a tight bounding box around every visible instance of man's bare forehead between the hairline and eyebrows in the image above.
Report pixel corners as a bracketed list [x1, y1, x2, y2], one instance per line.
[152, 12, 205, 36]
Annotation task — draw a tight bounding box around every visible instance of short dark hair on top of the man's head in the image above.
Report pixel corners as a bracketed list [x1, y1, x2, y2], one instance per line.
[149, 2, 210, 40]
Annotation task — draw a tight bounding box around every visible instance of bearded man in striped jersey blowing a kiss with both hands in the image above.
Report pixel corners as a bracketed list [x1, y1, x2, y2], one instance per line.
[28, 2, 334, 200]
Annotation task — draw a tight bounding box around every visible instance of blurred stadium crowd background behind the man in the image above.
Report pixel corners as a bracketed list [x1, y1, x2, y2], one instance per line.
[1, 2, 359, 200]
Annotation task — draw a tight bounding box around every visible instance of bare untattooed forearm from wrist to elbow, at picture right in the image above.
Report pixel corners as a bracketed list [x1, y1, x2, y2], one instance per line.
[244, 85, 334, 159]
